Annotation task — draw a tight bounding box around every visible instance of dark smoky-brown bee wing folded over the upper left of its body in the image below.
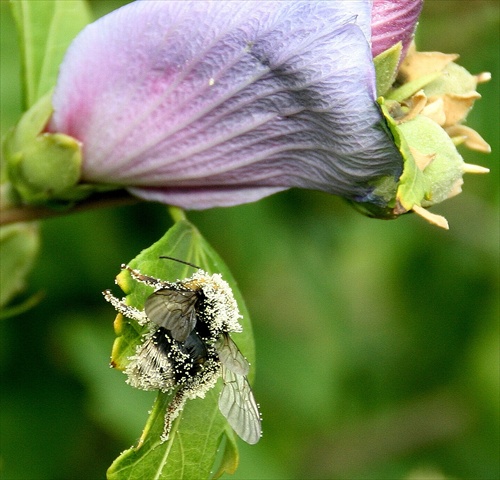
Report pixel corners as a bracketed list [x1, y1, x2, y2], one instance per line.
[144, 288, 198, 342]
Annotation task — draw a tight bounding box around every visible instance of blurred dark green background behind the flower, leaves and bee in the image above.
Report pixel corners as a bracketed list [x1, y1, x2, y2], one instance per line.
[0, 0, 500, 480]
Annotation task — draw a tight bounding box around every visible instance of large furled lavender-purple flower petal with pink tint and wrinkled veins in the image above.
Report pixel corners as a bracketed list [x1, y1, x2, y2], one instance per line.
[50, 0, 402, 208]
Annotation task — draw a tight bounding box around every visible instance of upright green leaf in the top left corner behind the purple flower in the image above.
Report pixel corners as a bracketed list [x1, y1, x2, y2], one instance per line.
[11, 0, 92, 108]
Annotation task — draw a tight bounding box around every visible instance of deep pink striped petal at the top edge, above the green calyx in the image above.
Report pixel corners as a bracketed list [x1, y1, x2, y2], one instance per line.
[372, 0, 423, 57]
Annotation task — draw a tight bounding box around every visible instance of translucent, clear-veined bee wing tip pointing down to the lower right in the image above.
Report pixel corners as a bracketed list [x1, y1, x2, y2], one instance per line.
[219, 364, 261, 445]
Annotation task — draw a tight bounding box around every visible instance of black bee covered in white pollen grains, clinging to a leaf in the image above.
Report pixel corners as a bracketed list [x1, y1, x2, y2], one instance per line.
[103, 257, 261, 444]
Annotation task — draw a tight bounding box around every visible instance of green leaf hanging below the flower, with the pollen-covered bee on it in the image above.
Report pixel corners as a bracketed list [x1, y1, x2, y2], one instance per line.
[108, 219, 255, 480]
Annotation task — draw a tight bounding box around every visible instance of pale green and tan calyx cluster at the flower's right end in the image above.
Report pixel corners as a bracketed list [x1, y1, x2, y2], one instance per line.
[375, 46, 491, 229]
